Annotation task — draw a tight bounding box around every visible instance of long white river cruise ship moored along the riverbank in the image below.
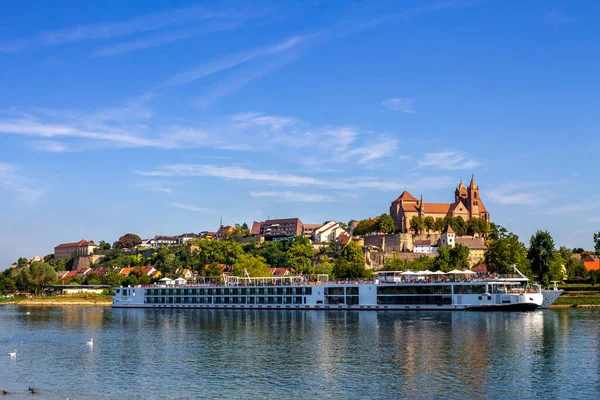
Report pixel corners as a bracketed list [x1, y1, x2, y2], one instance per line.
[112, 271, 543, 311]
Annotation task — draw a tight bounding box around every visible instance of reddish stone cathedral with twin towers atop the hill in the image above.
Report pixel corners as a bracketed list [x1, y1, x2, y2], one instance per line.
[390, 177, 490, 233]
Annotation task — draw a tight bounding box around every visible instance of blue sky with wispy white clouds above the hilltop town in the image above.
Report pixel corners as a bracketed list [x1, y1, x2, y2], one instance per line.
[0, 0, 600, 269]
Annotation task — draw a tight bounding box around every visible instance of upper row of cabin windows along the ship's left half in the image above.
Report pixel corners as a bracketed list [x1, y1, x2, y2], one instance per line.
[144, 287, 312, 296]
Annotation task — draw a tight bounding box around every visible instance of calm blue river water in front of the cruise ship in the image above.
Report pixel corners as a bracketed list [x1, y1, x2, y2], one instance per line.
[0, 306, 600, 399]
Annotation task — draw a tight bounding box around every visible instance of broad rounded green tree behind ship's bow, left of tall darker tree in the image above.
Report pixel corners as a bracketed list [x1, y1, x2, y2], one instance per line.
[485, 224, 529, 274]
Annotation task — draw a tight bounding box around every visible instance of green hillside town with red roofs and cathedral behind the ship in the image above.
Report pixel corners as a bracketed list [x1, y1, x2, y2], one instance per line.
[0, 177, 600, 294]
